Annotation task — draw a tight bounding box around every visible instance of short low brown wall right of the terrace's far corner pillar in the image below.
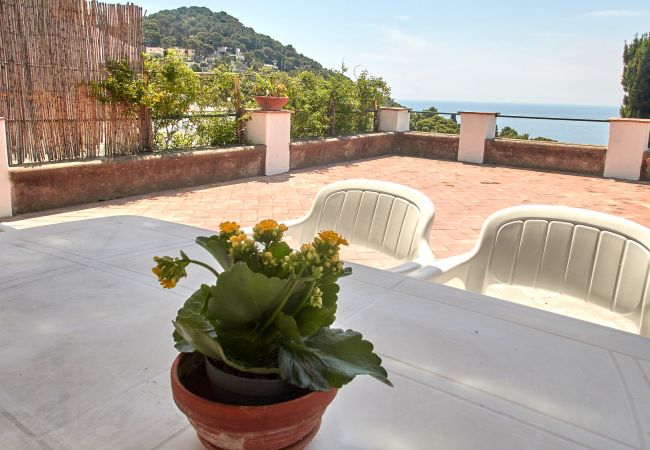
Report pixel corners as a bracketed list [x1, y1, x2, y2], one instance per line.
[395, 131, 459, 161]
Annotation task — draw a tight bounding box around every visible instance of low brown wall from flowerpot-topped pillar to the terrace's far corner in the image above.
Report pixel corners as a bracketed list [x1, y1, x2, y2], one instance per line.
[289, 133, 398, 170]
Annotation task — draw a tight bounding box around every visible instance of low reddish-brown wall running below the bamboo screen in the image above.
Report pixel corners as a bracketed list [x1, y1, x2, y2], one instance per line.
[9, 145, 266, 214]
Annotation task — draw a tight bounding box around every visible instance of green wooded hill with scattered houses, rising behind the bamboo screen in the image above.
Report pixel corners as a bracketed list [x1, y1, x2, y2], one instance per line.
[143, 6, 324, 72]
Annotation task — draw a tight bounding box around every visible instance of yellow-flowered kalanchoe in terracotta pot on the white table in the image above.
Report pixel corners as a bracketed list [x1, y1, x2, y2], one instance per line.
[153, 219, 391, 450]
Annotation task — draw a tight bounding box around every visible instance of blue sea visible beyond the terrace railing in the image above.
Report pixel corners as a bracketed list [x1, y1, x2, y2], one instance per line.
[397, 100, 619, 145]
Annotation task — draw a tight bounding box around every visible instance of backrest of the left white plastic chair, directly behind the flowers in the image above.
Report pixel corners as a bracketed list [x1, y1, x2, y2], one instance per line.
[290, 179, 434, 260]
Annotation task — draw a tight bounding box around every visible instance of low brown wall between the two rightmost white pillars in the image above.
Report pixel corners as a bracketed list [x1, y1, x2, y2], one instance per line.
[483, 139, 607, 176]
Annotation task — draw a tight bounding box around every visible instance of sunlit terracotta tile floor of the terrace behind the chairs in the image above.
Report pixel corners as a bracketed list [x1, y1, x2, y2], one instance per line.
[4, 156, 650, 266]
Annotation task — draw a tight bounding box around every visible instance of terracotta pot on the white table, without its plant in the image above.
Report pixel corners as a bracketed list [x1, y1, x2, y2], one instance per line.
[171, 353, 337, 450]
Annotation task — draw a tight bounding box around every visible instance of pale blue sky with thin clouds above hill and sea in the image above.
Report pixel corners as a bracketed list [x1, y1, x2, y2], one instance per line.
[132, 0, 650, 105]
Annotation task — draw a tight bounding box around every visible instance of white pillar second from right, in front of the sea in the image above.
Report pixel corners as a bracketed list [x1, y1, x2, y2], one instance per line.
[458, 111, 499, 164]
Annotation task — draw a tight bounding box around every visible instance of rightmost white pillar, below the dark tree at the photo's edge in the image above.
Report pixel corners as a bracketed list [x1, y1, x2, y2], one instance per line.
[603, 119, 650, 180]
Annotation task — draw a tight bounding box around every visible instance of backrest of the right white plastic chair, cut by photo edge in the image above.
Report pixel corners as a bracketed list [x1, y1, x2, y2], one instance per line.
[460, 205, 650, 335]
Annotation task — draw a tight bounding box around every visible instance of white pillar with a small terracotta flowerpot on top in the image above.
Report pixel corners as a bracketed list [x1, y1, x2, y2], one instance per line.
[244, 109, 292, 175]
